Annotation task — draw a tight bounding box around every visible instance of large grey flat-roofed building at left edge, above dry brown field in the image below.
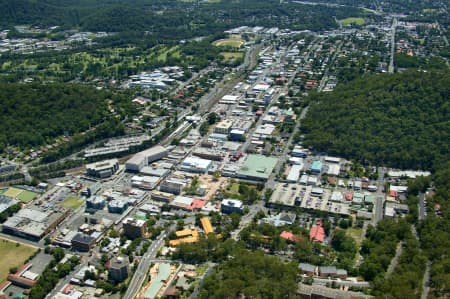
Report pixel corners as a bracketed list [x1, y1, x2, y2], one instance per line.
[2, 207, 69, 241]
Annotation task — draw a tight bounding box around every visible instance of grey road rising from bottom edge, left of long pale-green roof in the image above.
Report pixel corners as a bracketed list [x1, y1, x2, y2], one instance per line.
[123, 232, 166, 299]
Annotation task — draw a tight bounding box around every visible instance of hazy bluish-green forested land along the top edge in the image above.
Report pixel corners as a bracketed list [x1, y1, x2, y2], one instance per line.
[0, 0, 362, 33]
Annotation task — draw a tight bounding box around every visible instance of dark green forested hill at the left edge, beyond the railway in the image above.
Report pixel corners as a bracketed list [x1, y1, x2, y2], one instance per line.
[0, 84, 116, 150]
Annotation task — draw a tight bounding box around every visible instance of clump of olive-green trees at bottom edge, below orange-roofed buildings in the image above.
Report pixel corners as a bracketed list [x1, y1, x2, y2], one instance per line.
[198, 250, 298, 299]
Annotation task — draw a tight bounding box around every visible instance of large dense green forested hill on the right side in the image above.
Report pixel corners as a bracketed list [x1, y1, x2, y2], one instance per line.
[302, 71, 450, 170]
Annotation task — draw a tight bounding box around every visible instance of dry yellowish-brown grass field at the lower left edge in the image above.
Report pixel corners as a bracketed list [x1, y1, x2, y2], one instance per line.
[0, 239, 37, 283]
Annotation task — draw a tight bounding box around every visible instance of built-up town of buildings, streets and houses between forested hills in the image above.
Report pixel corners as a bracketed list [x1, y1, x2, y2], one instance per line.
[0, 1, 448, 299]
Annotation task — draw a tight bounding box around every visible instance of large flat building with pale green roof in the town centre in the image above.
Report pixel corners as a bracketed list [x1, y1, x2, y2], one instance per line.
[237, 155, 278, 181]
